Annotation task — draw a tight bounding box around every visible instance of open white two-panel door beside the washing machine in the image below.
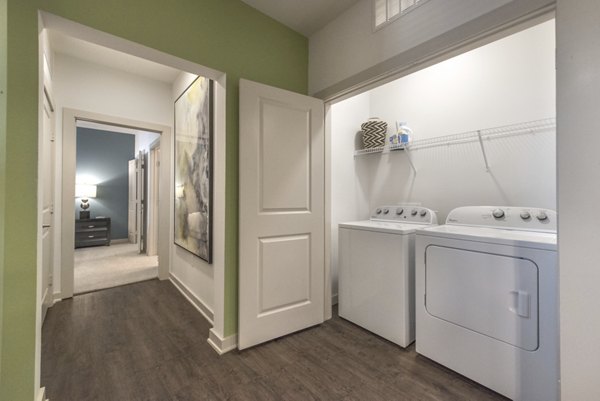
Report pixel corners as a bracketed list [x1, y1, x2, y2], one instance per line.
[238, 80, 325, 349]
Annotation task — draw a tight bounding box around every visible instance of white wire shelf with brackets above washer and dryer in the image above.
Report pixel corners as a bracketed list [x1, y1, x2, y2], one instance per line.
[354, 118, 556, 174]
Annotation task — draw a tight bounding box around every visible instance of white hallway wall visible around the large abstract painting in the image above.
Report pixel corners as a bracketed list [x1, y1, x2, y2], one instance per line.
[170, 72, 218, 313]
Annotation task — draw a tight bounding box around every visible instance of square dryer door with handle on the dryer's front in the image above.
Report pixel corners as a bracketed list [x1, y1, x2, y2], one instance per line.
[425, 245, 538, 351]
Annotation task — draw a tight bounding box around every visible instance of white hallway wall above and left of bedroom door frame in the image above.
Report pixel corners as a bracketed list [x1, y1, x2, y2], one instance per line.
[53, 53, 173, 294]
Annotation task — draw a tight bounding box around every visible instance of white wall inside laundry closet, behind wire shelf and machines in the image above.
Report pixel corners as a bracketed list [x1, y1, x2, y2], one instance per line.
[332, 20, 556, 296]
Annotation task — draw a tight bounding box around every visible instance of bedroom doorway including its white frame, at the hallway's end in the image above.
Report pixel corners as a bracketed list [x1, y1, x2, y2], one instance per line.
[61, 109, 171, 297]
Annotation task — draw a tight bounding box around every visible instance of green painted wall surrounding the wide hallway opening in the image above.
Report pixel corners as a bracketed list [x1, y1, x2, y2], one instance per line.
[0, 0, 308, 401]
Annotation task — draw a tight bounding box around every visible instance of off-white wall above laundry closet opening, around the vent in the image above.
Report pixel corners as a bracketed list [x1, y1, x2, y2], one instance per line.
[309, 0, 553, 94]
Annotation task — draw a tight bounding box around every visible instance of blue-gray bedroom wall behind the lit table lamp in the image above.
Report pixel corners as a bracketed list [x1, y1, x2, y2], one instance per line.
[75, 127, 135, 239]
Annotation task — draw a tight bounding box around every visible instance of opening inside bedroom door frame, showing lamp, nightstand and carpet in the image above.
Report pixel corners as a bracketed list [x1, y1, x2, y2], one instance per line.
[73, 121, 160, 294]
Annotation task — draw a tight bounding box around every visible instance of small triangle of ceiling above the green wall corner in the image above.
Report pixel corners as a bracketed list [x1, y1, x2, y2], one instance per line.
[242, 0, 360, 36]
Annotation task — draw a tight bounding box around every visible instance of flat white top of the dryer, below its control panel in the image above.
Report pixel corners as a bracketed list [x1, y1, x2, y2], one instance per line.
[417, 224, 556, 251]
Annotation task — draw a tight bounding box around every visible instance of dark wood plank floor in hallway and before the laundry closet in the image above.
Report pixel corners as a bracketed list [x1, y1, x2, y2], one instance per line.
[42, 280, 505, 401]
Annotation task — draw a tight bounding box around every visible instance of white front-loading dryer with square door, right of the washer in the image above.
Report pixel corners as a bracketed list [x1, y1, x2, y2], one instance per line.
[416, 206, 559, 401]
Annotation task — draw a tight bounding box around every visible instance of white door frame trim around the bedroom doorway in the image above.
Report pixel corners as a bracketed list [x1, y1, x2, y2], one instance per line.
[60, 108, 172, 299]
